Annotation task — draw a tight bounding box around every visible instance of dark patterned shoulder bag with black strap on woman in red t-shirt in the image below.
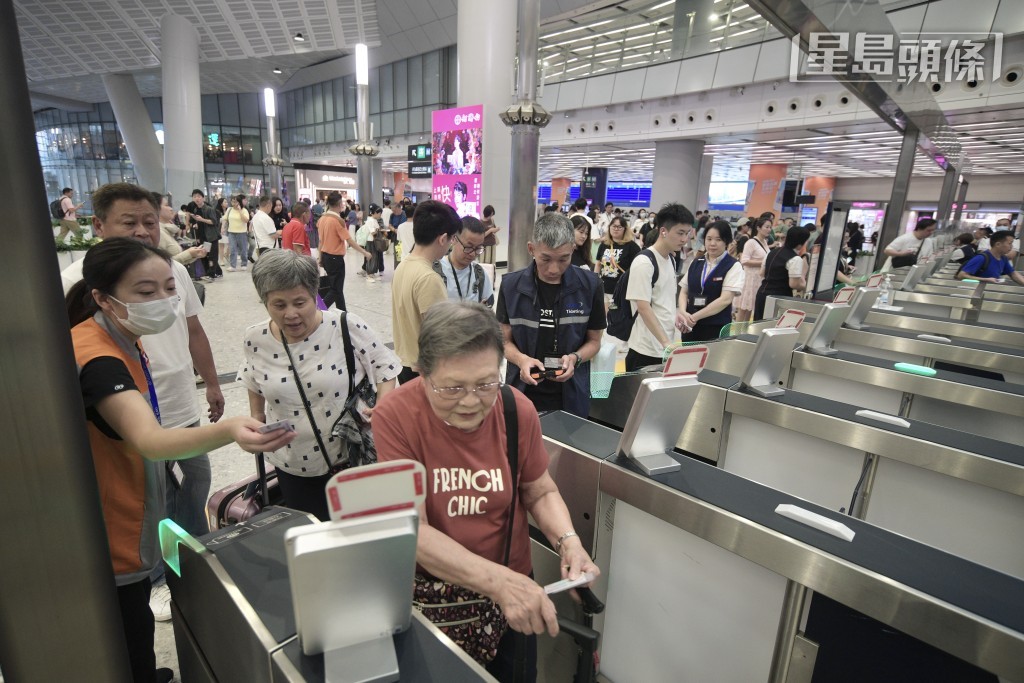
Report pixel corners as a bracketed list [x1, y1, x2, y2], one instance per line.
[413, 386, 519, 667]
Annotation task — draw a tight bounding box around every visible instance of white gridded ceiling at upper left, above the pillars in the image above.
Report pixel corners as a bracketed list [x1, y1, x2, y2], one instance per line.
[14, 0, 608, 102]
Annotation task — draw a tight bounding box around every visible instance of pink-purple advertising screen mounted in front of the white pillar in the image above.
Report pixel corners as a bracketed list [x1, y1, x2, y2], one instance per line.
[430, 104, 483, 218]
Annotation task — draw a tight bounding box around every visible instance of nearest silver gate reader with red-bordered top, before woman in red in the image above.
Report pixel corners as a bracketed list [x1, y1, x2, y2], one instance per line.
[285, 461, 425, 683]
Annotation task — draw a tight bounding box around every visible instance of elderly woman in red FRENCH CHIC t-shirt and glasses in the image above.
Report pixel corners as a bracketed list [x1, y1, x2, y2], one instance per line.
[374, 301, 599, 680]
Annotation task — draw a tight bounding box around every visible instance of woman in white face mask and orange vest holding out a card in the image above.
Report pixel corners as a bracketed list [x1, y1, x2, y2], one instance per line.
[66, 238, 295, 683]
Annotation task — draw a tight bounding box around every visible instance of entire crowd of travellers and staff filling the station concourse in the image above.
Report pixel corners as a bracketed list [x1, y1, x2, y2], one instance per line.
[61, 183, 1021, 683]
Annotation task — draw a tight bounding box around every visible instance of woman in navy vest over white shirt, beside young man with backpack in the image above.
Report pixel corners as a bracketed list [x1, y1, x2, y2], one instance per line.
[676, 220, 743, 342]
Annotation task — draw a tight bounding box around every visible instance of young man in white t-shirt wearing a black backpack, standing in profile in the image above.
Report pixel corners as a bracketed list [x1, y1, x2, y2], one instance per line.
[609, 204, 693, 372]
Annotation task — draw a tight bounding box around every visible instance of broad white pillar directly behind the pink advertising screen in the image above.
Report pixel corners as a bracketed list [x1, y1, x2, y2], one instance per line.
[458, 0, 517, 261]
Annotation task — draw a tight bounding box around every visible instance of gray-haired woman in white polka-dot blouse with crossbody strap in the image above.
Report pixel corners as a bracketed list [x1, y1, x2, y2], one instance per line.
[239, 249, 401, 521]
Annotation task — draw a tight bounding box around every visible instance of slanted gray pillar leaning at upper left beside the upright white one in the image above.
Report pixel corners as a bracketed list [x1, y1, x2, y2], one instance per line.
[103, 74, 164, 193]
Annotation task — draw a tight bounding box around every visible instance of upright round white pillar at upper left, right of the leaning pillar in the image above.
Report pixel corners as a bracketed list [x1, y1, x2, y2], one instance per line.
[160, 14, 206, 205]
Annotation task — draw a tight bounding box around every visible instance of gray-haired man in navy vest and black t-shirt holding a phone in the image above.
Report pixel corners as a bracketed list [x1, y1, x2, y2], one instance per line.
[497, 212, 605, 418]
